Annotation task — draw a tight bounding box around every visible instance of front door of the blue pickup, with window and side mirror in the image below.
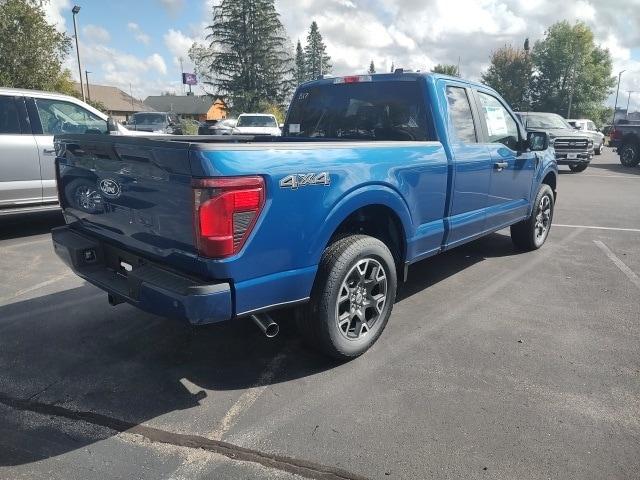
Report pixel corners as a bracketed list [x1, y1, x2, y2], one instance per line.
[474, 90, 537, 230]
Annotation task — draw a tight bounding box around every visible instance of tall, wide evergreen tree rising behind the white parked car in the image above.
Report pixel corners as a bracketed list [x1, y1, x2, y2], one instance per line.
[189, 0, 294, 112]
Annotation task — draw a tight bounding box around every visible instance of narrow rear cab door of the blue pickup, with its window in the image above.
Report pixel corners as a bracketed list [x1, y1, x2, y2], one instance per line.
[444, 82, 493, 248]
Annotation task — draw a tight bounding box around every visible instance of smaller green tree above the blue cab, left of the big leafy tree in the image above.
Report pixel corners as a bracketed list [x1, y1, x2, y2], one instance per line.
[482, 45, 533, 111]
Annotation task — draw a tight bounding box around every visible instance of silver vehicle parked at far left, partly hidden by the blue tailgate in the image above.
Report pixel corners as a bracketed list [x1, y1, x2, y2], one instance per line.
[0, 88, 155, 216]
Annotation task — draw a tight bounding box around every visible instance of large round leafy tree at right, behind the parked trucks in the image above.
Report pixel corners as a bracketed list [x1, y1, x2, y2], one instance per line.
[531, 21, 615, 118]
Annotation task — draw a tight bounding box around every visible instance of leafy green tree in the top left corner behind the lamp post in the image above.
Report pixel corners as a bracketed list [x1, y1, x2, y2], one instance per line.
[0, 0, 71, 90]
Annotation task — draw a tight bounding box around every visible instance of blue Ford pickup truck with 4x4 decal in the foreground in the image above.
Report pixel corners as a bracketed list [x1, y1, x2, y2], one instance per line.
[52, 72, 557, 358]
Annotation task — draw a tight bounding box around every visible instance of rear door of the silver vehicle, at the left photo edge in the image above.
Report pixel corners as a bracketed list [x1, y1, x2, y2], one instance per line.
[0, 95, 42, 208]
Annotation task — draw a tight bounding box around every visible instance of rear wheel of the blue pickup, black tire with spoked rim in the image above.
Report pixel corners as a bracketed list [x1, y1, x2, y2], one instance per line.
[297, 235, 397, 360]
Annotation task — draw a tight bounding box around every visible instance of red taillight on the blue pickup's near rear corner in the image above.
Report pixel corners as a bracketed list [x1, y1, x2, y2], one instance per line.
[192, 177, 265, 258]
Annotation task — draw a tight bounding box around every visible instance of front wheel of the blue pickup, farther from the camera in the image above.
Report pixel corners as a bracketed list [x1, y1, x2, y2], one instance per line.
[511, 183, 555, 251]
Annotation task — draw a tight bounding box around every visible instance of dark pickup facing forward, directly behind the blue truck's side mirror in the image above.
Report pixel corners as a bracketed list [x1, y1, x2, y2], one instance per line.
[517, 112, 594, 172]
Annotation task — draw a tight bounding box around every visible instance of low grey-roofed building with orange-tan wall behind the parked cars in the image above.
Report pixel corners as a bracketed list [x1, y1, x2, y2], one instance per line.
[144, 95, 227, 122]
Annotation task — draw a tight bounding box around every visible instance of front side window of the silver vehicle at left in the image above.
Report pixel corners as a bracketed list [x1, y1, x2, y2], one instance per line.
[36, 98, 107, 135]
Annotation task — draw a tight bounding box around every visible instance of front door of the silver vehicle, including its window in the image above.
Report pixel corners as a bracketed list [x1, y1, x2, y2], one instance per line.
[27, 98, 107, 202]
